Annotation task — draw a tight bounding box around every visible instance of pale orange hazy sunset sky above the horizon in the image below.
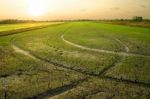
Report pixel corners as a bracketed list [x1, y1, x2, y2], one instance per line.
[0, 0, 150, 20]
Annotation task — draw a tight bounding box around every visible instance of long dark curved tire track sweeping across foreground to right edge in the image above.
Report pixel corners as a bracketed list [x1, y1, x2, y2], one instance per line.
[13, 44, 150, 88]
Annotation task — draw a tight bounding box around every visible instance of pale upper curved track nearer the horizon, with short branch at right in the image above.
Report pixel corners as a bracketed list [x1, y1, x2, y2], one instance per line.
[61, 35, 150, 57]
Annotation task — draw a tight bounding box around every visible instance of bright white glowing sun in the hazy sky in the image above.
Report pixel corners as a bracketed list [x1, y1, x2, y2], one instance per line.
[28, 0, 47, 16]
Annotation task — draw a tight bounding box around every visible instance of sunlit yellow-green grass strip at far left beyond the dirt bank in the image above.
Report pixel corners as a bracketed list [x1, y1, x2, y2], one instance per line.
[0, 22, 63, 36]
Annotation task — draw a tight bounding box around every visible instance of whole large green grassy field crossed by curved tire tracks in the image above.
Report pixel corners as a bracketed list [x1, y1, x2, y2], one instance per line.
[0, 22, 150, 99]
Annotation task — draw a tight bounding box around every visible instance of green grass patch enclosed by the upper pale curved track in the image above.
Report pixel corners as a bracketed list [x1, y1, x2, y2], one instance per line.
[64, 23, 124, 51]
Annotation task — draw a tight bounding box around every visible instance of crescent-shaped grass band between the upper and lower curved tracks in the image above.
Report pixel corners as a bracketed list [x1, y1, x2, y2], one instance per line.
[14, 22, 119, 74]
